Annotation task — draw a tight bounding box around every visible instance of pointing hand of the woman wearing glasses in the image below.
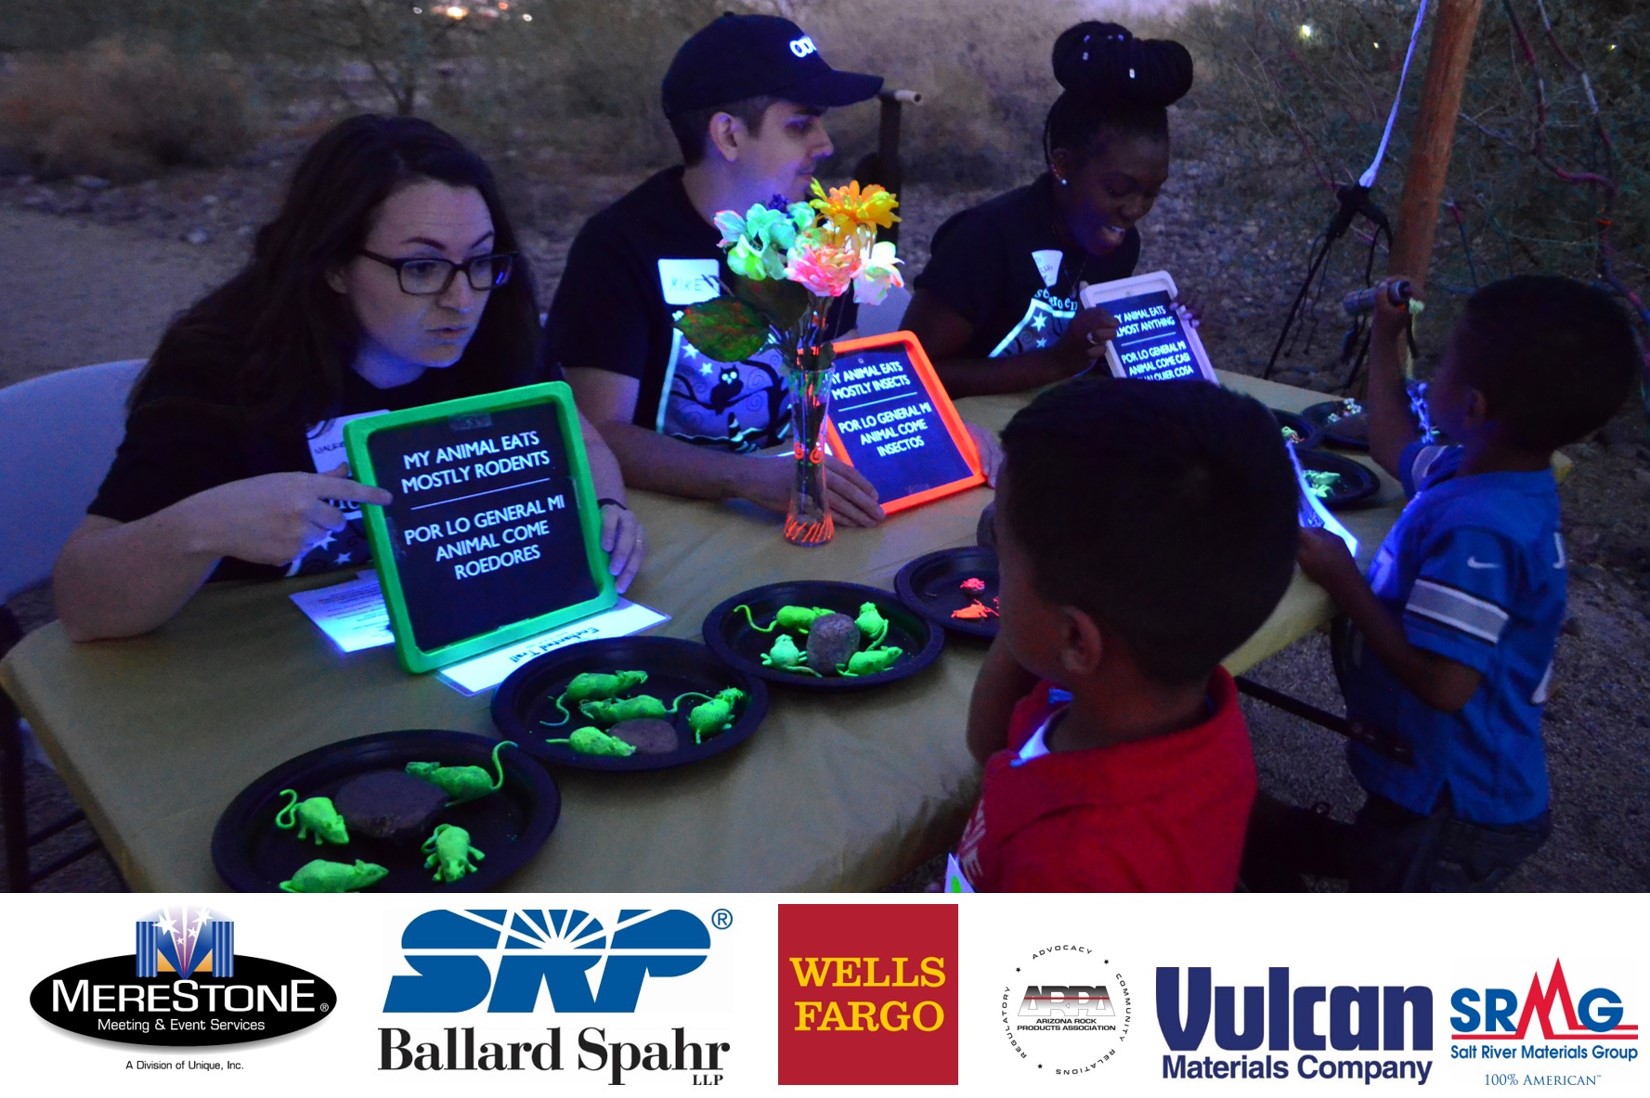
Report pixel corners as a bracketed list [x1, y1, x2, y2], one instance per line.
[185, 464, 394, 565]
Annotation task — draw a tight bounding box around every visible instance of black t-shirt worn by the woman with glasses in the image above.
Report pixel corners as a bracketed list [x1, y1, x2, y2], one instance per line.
[86, 355, 472, 580]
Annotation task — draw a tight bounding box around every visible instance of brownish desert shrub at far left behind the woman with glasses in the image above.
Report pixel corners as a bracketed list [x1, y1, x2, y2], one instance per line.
[0, 40, 252, 180]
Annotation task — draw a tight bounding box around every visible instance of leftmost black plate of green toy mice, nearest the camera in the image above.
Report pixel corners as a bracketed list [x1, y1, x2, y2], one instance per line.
[211, 728, 561, 892]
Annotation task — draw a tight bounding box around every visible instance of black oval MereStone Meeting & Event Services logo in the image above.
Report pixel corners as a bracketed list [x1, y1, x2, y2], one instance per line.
[28, 906, 338, 1045]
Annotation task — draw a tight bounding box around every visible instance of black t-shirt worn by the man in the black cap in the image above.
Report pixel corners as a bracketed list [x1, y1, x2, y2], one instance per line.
[546, 167, 858, 454]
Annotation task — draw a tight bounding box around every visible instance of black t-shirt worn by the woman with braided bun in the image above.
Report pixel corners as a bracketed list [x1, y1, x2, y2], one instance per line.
[914, 175, 1140, 358]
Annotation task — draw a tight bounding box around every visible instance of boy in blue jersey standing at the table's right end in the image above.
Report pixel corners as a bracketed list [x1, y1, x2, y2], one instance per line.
[1246, 276, 1638, 890]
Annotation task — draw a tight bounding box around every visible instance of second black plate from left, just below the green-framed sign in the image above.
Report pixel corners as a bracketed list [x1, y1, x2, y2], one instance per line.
[493, 637, 767, 771]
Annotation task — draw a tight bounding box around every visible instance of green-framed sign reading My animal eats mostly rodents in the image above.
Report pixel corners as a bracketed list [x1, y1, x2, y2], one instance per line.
[343, 381, 619, 672]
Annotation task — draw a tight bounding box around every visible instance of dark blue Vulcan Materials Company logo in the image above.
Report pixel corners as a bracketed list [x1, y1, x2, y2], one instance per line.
[1157, 966, 1432, 1086]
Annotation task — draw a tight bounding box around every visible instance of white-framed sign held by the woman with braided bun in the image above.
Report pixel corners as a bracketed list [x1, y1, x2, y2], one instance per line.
[1082, 271, 1214, 381]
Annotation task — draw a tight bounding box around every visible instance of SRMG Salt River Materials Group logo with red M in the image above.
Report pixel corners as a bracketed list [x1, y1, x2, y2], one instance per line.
[1449, 961, 1638, 1085]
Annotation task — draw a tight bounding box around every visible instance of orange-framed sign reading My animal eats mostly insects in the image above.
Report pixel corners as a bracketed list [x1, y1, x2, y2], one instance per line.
[825, 332, 985, 514]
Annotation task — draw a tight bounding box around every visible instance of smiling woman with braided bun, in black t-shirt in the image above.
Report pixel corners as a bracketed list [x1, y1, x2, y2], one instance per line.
[903, 21, 1191, 396]
